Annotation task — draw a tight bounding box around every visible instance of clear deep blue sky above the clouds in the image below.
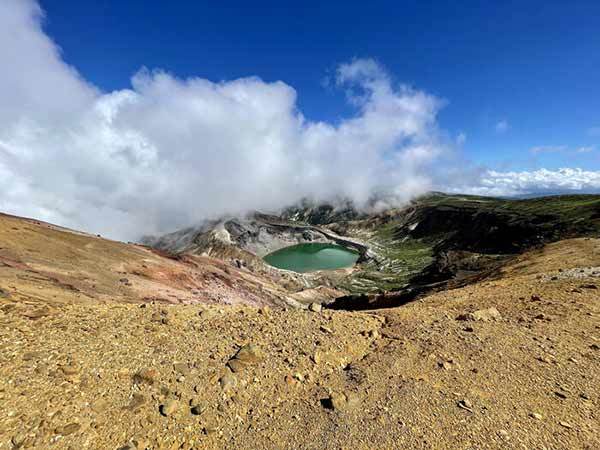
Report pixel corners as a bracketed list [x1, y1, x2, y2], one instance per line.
[41, 0, 600, 170]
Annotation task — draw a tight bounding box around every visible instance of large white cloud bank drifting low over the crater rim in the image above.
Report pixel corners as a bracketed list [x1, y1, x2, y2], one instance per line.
[0, 0, 444, 239]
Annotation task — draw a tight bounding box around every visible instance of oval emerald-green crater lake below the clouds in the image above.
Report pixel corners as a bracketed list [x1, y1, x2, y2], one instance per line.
[264, 244, 359, 272]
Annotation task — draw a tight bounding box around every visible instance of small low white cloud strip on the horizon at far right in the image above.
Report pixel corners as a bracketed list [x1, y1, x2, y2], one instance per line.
[450, 168, 600, 196]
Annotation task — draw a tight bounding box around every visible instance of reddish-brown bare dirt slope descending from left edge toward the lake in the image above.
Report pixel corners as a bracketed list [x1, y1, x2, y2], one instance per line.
[0, 214, 304, 305]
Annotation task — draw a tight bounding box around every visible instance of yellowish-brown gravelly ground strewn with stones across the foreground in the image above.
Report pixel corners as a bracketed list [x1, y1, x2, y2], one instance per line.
[0, 222, 600, 449]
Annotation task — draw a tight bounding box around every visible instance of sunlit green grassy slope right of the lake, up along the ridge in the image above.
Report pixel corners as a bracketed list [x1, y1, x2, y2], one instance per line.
[342, 193, 600, 293]
